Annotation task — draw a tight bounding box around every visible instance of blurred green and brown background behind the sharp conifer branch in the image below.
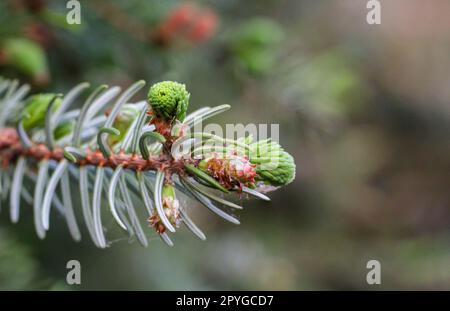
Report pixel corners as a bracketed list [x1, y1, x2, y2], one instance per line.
[0, 0, 450, 290]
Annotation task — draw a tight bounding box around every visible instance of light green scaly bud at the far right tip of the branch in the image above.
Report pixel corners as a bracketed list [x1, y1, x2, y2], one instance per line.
[250, 140, 295, 186]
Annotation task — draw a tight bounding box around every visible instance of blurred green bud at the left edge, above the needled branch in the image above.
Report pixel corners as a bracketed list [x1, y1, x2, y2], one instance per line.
[1, 38, 49, 82]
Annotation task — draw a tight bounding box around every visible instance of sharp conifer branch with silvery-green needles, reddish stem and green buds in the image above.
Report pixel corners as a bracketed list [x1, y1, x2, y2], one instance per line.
[0, 79, 295, 248]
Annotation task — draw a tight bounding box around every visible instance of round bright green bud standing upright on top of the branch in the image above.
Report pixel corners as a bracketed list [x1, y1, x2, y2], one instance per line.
[147, 81, 190, 122]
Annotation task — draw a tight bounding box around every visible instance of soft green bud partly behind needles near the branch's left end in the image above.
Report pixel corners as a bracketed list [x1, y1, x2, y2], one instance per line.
[23, 93, 61, 130]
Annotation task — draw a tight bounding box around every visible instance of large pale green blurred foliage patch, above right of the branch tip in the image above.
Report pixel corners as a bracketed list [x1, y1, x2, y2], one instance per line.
[275, 50, 368, 118]
